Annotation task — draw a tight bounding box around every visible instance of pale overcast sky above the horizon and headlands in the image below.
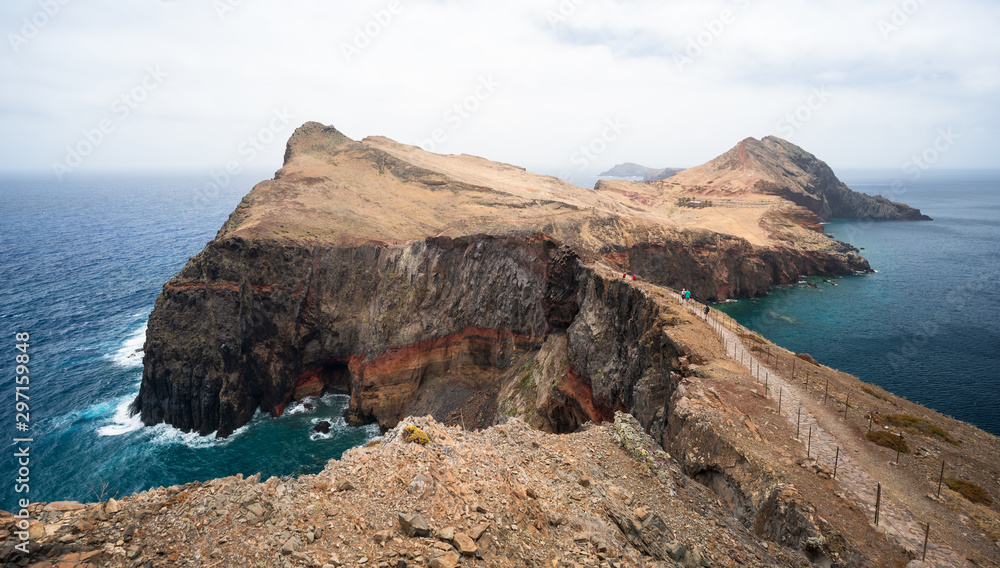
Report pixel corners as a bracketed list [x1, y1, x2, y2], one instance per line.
[0, 0, 1000, 181]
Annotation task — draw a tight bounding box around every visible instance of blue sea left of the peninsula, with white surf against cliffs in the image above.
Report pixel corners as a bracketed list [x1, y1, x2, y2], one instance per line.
[0, 173, 378, 510]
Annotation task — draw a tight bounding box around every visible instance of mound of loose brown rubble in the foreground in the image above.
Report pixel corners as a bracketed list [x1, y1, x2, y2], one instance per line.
[0, 414, 905, 568]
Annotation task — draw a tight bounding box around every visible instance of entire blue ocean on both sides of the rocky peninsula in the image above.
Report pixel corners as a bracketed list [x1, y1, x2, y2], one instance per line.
[0, 168, 1000, 510]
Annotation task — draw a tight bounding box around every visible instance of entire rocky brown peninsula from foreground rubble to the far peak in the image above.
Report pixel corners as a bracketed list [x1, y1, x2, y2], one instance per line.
[7, 123, 1000, 568]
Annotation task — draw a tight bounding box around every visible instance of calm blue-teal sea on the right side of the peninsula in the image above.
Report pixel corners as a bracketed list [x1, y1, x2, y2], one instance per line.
[719, 171, 1000, 435]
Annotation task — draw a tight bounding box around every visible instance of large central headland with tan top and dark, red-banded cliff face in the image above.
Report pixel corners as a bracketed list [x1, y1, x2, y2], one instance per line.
[133, 123, 884, 436]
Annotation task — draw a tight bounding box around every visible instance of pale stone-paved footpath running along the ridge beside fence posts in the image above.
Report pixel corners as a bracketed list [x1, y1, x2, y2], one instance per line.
[676, 295, 972, 568]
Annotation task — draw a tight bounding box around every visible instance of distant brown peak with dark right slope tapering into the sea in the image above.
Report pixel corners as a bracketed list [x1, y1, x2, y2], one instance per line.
[669, 136, 930, 220]
